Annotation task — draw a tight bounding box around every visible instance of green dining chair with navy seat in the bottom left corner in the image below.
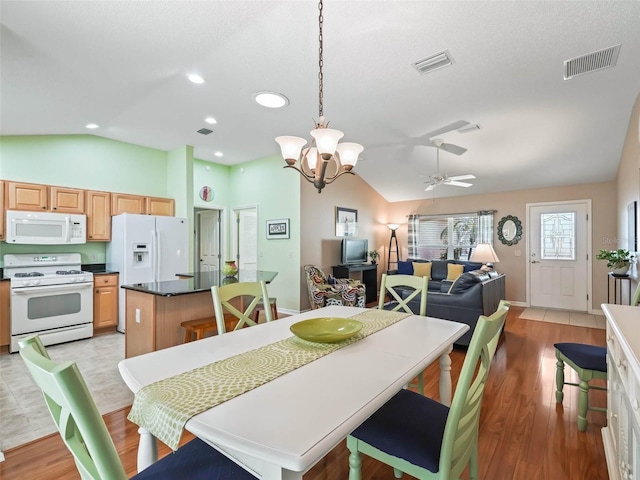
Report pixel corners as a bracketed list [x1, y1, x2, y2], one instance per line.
[19, 335, 256, 480]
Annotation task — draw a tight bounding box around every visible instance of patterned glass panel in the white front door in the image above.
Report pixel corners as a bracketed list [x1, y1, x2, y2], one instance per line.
[540, 212, 576, 260]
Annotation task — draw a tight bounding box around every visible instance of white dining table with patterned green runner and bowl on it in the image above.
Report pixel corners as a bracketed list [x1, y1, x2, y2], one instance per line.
[118, 306, 469, 480]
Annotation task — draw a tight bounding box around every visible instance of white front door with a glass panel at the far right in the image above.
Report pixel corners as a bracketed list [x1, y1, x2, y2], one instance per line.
[527, 200, 591, 311]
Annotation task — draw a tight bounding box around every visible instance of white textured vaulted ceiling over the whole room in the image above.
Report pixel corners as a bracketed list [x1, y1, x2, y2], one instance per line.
[0, 0, 640, 201]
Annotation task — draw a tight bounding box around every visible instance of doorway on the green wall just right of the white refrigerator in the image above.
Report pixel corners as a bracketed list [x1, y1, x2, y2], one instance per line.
[195, 209, 224, 272]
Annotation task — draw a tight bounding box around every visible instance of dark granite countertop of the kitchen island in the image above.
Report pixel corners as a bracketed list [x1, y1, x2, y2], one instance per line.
[122, 270, 278, 297]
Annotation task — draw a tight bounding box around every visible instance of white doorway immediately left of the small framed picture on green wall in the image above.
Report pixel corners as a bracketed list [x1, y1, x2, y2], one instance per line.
[232, 206, 258, 280]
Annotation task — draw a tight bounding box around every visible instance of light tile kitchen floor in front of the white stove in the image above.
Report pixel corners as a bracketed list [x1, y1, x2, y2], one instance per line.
[0, 333, 133, 451]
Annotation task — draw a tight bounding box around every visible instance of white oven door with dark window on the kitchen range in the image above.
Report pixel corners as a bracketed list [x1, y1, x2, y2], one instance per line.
[11, 283, 93, 335]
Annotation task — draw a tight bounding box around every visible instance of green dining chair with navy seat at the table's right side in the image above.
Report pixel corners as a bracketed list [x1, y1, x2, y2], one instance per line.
[347, 302, 509, 480]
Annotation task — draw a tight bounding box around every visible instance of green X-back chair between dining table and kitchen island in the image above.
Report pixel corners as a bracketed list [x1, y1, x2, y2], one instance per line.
[211, 281, 273, 335]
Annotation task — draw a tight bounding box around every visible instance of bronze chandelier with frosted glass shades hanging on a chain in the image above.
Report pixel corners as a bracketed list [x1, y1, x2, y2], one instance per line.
[276, 0, 364, 193]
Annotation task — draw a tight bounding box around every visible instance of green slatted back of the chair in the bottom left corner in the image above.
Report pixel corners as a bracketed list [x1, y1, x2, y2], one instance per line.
[19, 336, 127, 480]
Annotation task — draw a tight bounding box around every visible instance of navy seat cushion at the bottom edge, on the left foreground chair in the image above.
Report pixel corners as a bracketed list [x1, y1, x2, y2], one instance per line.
[131, 438, 256, 480]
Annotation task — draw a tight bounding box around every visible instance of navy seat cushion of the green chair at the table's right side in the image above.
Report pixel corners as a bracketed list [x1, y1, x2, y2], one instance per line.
[351, 390, 449, 473]
